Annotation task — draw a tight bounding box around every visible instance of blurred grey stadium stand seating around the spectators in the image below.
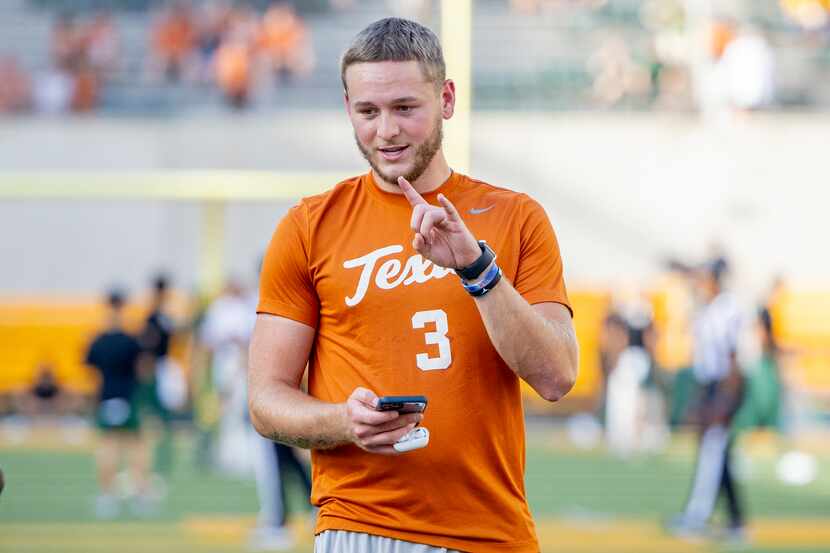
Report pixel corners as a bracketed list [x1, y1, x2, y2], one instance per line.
[0, 0, 830, 114]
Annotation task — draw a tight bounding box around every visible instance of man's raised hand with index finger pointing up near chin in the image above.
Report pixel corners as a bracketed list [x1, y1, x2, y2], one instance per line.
[398, 177, 481, 269]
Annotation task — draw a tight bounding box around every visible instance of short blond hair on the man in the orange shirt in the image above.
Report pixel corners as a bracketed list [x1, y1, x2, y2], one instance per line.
[340, 17, 447, 90]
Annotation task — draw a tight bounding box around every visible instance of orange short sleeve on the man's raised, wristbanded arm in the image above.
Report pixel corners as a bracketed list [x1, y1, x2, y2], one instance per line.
[513, 197, 573, 315]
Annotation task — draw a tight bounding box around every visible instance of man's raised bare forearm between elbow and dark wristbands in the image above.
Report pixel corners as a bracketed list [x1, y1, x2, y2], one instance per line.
[476, 279, 578, 401]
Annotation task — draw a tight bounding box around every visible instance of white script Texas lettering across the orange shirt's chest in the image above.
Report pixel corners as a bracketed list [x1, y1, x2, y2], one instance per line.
[343, 244, 454, 307]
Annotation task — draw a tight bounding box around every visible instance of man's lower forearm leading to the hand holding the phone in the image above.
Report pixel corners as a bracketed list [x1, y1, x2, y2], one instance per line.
[248, 383, 349, 449]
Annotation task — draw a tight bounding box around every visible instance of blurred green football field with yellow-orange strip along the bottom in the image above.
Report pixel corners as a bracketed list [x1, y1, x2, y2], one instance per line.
[0, 426, 830, 553]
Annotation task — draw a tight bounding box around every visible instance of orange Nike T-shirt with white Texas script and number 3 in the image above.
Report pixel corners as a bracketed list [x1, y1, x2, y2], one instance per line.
[257, 173, 570, 553]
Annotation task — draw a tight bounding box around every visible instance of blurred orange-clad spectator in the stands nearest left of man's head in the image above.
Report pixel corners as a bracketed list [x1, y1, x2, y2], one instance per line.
[259, 3, 314, 82]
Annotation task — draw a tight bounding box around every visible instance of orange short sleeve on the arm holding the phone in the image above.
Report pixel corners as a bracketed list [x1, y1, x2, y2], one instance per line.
[257, 204, 320, 328]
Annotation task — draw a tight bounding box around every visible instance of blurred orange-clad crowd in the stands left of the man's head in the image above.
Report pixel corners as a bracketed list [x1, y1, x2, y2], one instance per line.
[0, 0, 314, 114]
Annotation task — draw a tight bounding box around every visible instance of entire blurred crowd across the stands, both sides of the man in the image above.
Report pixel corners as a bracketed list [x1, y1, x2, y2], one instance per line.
[0, 0, 830, 118]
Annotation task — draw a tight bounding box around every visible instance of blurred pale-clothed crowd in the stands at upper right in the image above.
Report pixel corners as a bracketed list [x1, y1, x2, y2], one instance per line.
[588, 12, 775, 115]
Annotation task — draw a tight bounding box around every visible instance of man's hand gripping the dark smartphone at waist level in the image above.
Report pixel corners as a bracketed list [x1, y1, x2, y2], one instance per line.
[346, 388, 423, 455]
